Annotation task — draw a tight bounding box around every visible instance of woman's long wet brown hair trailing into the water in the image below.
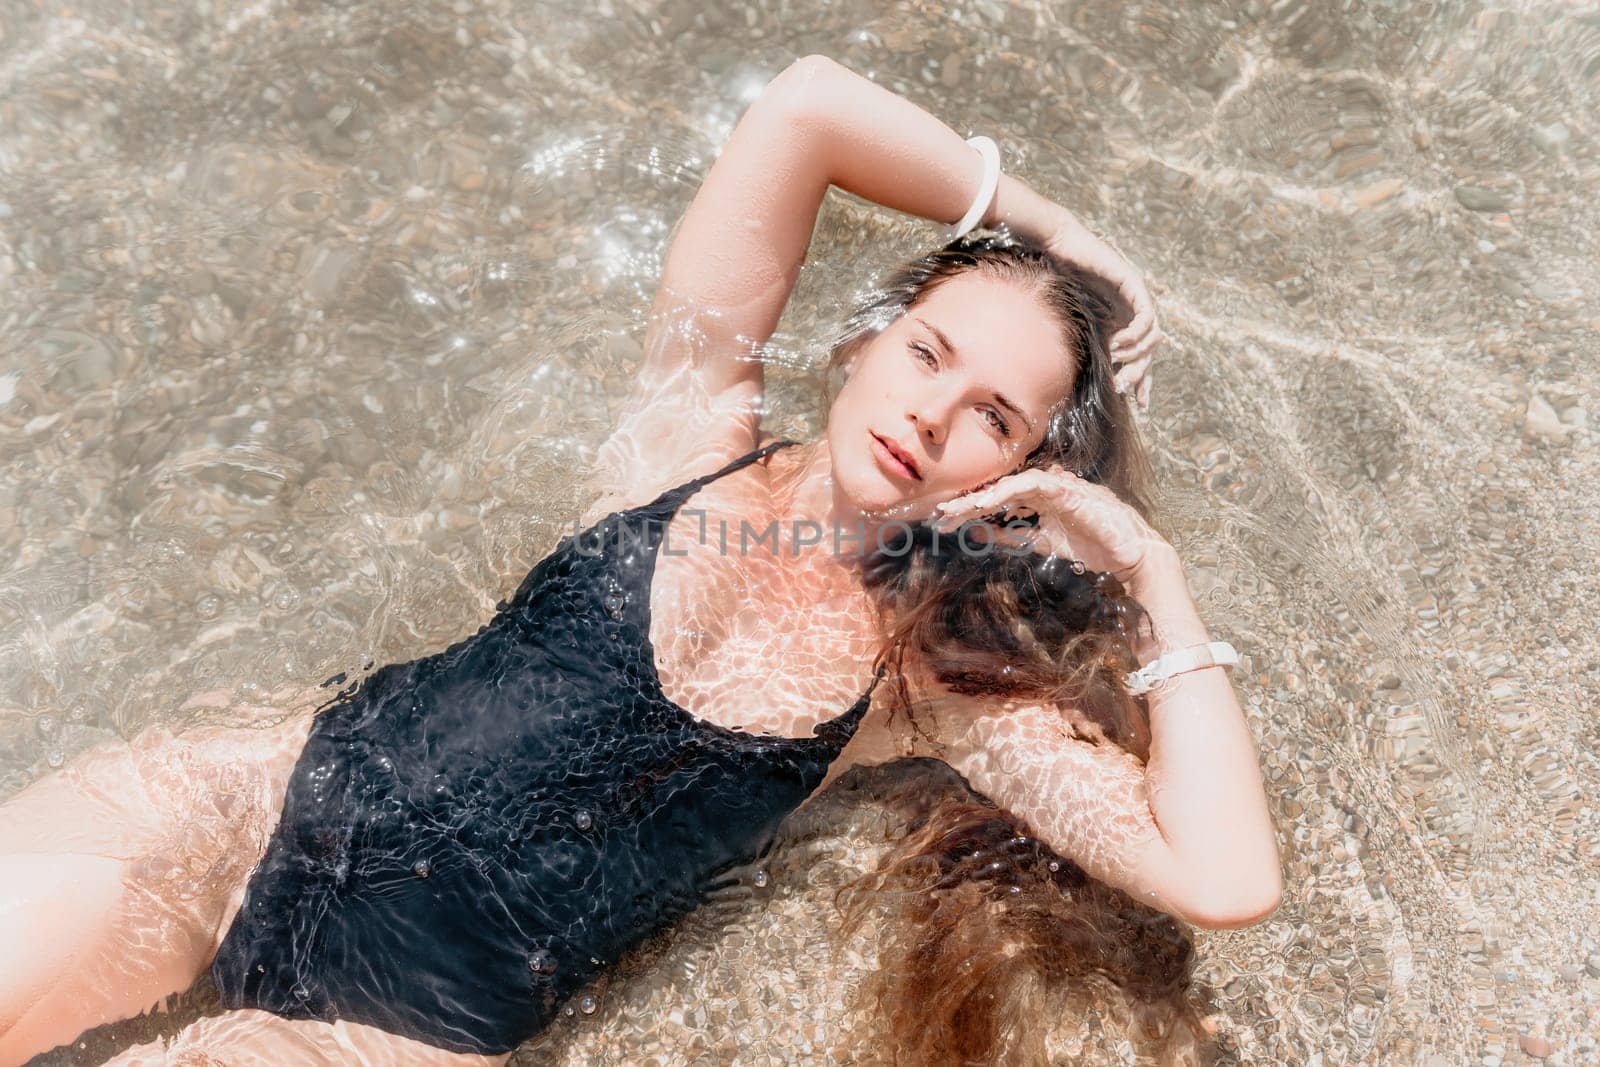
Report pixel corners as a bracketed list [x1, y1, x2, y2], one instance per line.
[827, 234, 1211, 1064]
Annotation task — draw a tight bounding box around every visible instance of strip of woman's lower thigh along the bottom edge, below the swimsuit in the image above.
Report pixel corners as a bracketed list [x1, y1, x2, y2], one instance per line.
[106, 1011, 509, 1067]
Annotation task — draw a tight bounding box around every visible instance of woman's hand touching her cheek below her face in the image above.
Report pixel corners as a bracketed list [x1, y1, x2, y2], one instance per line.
[934, 466, 1173, 584]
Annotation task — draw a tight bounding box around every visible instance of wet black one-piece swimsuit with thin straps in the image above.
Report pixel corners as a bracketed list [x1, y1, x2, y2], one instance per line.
[211, 442, 883, 1053]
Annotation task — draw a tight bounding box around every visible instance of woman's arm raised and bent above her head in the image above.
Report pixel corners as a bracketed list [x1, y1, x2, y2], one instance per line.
[590, 56, 1152, 517]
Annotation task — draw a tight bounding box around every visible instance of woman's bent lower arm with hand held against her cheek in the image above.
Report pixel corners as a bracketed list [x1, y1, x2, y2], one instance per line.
[942, 469, 1283, 926]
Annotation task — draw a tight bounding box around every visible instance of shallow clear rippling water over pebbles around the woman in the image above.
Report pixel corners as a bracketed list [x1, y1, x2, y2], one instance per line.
[0, 0, 1600, 1064]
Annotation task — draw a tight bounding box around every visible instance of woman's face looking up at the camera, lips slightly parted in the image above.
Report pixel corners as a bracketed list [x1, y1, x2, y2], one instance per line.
[827, 270, 1074, 518]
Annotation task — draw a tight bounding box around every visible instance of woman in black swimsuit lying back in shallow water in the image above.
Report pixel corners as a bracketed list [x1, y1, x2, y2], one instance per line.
[0, 56, 1278, 1062]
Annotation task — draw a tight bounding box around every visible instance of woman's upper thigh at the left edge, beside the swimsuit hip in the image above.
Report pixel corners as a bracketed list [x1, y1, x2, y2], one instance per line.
[0, 691, 330, 1065]
